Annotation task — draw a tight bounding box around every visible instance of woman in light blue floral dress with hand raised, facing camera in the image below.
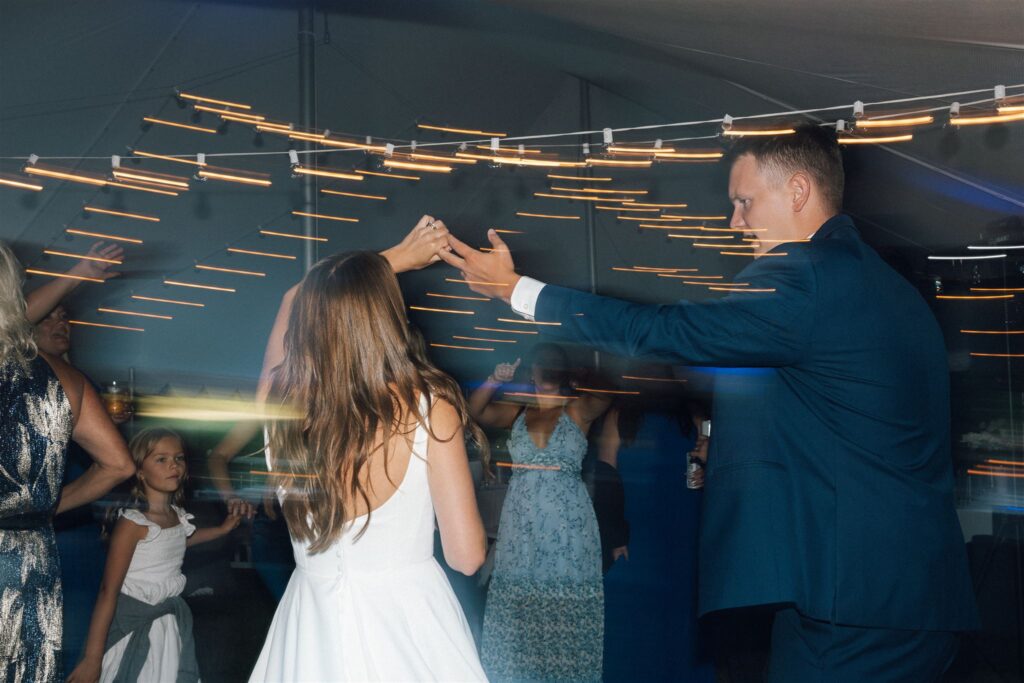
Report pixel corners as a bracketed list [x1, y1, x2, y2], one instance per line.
[469, 344, 610, 681]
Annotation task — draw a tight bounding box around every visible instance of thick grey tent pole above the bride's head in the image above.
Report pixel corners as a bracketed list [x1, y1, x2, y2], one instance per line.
[298, 0, 317, 271]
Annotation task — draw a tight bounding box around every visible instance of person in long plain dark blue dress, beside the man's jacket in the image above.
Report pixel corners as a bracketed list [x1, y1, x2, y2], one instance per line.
[598, 394, 715, 683]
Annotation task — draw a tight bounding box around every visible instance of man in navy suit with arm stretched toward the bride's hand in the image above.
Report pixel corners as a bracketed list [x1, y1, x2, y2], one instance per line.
[441, 126, 978, 683]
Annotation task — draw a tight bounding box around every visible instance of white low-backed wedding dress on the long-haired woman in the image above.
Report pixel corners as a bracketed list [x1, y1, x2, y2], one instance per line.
[249, 400, 486, 683]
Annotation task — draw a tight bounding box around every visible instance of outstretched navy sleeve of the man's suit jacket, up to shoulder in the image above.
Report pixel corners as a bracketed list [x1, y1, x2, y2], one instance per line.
[537, 245, 817, 367]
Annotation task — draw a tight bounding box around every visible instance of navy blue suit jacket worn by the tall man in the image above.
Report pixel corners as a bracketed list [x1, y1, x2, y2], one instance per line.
[536, 215, 977, 631]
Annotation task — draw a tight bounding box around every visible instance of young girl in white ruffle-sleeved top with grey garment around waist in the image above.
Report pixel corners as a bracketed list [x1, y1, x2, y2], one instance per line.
[68, 428, 241, 683]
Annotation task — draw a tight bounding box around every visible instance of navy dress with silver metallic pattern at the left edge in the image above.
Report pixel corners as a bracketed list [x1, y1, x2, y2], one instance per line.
[0, 357, 73, 682]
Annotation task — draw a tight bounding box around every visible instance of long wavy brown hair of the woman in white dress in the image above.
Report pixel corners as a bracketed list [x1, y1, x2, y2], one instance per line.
[268, 252, 488, 553]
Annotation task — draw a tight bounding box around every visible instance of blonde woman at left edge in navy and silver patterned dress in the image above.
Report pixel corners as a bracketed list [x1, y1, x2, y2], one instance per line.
[0, 243, 134, 681]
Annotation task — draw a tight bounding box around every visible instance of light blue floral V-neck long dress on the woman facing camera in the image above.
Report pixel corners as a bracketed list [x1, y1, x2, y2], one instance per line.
[481, 413, 604, 681]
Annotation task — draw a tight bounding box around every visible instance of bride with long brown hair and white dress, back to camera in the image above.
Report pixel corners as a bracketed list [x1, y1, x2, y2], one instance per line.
[250, 252, 486, 681]
